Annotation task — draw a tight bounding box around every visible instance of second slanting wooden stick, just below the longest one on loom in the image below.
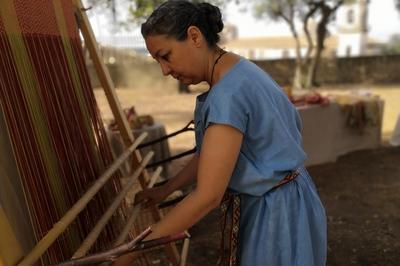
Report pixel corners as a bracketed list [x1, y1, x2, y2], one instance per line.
[72, 151, 154, 259]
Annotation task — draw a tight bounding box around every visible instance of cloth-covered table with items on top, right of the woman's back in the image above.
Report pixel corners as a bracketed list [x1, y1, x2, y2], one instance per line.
[297, 100, 384, 166]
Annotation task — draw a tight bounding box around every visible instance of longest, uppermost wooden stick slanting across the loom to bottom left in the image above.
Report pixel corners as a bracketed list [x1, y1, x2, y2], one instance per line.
[18, 132, 147, 266]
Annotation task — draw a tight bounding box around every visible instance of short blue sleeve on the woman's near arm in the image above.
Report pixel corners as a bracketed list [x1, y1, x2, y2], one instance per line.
[204, 93, 250, 134]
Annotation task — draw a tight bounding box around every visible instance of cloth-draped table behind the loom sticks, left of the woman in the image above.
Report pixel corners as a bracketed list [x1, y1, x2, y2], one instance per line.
[107, 123, 170, 177]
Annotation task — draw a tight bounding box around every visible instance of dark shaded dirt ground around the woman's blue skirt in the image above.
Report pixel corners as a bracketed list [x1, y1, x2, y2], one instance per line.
[184, 147, 400, 266]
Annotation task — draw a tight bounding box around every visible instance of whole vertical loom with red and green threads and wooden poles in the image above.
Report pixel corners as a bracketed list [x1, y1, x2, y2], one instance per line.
[0, 0, 188, 266]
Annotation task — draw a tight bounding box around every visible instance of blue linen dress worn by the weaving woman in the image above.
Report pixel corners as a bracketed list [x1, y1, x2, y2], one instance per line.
[194, 58, 327, 266]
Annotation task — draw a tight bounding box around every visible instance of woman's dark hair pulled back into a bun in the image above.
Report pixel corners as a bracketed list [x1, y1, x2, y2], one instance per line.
[141, 0, 224, 47]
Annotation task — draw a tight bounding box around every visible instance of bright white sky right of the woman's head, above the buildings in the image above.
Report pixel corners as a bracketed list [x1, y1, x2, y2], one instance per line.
[224, 0, 400, 41]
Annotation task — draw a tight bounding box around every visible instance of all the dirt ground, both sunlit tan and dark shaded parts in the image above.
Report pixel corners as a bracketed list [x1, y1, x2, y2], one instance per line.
[95, 86, 400, 266]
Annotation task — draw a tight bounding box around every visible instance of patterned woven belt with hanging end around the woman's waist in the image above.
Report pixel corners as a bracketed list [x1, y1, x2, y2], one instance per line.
[218, 170, 299, 266]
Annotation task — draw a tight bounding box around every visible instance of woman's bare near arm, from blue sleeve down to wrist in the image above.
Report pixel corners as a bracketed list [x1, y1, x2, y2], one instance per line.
[147, 124, 243, 239]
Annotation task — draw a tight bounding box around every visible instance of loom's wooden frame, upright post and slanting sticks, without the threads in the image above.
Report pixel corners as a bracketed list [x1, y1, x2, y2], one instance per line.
[18, 0, 189, 266]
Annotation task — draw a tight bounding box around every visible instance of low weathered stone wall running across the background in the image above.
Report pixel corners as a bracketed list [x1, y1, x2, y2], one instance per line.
[88, 55, 400, 88]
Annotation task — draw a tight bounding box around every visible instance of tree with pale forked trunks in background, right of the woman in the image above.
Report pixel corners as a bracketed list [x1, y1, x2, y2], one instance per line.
[253, 0, 350, 89]
